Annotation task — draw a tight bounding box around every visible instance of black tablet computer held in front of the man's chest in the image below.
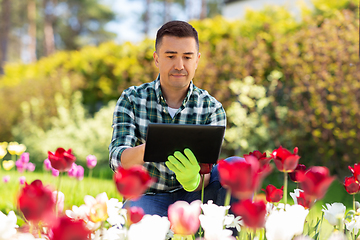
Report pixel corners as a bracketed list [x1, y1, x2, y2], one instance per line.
[144, 123, 225, 163]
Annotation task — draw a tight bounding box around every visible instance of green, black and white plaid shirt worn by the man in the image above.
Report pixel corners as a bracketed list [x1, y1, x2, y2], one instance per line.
[109, 75, 226, 193]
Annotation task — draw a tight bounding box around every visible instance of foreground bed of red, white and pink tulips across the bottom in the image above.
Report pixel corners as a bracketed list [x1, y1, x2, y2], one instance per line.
[0, 144, 360, 240]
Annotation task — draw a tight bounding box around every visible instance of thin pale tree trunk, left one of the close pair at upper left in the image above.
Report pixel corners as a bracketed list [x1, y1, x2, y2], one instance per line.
[27, 0, 36, 62]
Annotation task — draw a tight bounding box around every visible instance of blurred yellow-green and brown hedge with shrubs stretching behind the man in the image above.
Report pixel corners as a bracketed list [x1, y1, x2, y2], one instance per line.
[0, 0, 360, 176]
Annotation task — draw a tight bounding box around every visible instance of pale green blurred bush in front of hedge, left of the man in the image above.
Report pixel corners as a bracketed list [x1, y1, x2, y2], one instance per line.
[13, 80, 115, 177]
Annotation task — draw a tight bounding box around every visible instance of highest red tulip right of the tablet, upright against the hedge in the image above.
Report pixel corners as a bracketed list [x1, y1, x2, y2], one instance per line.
[271, 146, 300, 172]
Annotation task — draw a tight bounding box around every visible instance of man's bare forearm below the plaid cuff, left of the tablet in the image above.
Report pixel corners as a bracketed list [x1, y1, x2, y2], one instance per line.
[120, 143, 145, 168]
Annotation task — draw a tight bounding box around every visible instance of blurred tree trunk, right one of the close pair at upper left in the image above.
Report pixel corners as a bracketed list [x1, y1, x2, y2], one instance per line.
[44, 0, 57, 56]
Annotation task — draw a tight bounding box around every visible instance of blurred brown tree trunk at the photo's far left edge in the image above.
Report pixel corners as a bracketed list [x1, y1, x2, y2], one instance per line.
[0, 0, 11, 75]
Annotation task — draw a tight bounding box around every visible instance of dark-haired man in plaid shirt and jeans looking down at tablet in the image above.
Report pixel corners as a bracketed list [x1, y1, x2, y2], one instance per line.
[109, 21, 226, 216]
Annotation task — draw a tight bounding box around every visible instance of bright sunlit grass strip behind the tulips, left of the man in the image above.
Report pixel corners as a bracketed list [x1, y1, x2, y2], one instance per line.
[0, 169, 122, 213]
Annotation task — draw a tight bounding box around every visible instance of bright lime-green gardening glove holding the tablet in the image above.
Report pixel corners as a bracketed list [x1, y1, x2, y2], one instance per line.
[165, 148, 200, 192]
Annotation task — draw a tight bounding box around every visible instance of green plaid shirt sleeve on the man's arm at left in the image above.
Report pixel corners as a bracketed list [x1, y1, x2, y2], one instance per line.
[109, 92, 137, 172]
